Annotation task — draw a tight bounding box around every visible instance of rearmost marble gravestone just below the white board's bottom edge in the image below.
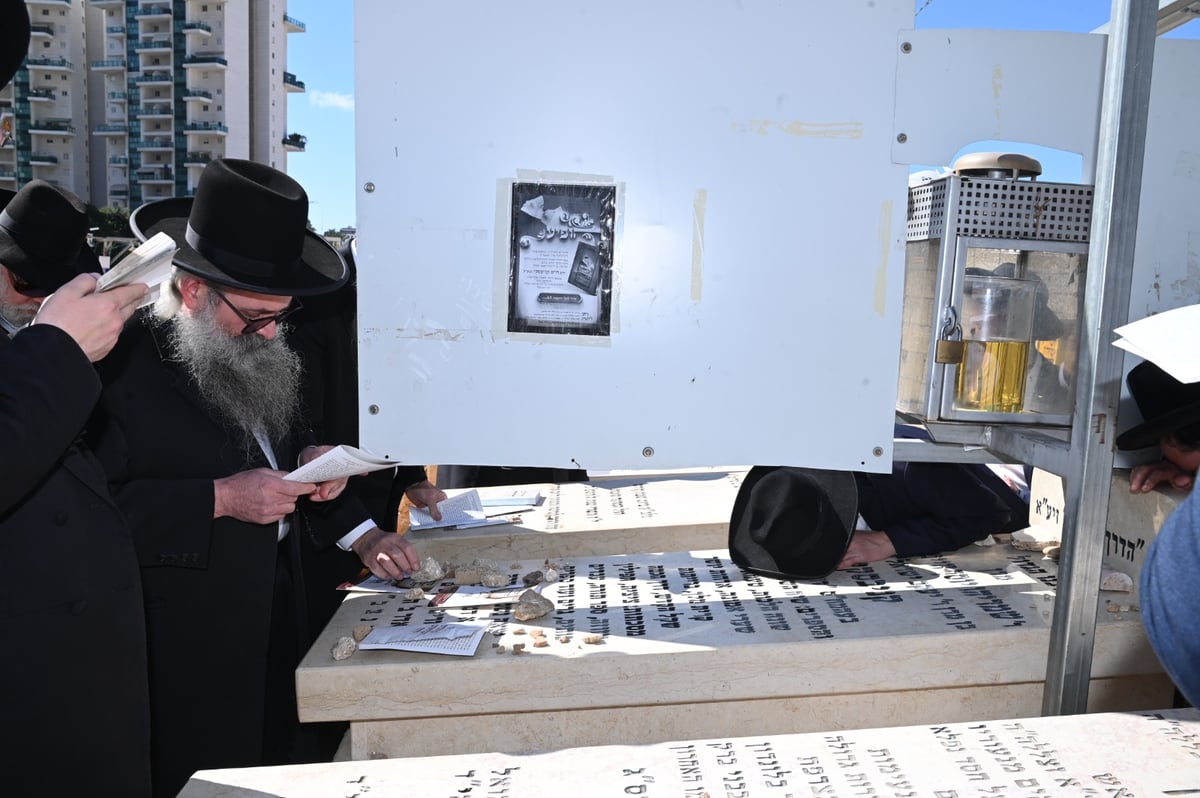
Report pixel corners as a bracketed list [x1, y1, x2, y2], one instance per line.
[408, 469, 746, 562]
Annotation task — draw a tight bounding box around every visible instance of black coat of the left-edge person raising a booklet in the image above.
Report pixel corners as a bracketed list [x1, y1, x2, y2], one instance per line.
[0, 325, 150, 796]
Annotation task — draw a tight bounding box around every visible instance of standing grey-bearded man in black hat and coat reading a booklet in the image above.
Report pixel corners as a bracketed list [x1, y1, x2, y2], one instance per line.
[87, 158, 419, 796]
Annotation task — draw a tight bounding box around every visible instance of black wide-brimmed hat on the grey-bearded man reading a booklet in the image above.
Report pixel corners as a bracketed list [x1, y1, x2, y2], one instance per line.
[130, 158, 347, 296]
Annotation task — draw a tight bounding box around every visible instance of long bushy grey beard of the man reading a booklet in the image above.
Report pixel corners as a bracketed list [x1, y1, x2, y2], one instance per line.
[168, 298, 302, 449]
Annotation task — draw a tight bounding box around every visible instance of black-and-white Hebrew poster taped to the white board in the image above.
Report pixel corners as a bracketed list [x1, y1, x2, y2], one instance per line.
[509, 182, 617, 336]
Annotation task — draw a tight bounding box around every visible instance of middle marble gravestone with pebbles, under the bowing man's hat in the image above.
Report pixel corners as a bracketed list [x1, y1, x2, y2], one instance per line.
[296, 546, 1171, 758]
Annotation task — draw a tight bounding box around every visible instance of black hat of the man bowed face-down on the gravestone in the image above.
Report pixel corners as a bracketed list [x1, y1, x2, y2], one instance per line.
[730, 466, 858, 580]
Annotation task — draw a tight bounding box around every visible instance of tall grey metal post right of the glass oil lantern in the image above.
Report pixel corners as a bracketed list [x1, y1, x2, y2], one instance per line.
[1042, 0, 1158, 715]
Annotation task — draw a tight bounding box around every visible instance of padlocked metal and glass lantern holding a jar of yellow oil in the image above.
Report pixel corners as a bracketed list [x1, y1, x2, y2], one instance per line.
[898, 152, 1092, 437]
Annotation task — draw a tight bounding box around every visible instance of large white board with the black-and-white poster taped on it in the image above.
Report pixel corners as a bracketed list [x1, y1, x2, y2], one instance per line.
[355, 0, 913, 470]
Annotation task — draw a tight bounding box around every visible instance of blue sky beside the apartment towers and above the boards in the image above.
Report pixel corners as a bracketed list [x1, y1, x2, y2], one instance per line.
[288, 0, 1200, 232]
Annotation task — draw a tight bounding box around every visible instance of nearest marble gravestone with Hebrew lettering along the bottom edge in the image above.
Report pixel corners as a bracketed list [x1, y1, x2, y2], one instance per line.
[180, 709, 1200, 798]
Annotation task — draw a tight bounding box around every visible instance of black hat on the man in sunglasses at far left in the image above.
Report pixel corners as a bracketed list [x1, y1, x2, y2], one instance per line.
[0, 180, 101, 293]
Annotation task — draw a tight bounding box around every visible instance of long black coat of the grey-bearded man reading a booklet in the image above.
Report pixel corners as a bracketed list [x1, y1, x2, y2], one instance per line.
[92, 317, 366, 796]
